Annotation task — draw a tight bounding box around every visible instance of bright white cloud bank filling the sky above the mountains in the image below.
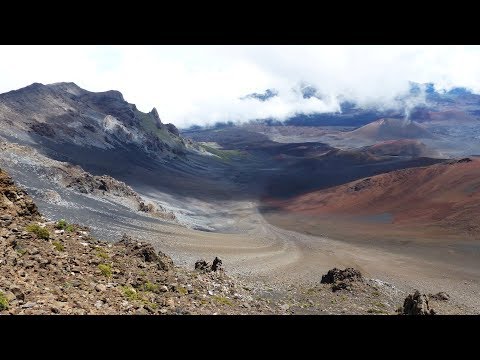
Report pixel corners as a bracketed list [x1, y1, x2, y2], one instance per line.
[0, 46, 480, 126]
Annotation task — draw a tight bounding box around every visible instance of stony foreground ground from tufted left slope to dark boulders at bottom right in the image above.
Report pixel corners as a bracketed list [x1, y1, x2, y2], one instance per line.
[0, 170, 461, 315]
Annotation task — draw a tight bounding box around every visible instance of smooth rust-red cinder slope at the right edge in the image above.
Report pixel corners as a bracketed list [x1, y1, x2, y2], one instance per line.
[270, 158, 480, 237]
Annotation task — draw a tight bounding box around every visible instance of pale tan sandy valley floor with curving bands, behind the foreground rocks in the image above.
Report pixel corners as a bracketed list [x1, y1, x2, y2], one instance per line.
[119, 203, 480, 314]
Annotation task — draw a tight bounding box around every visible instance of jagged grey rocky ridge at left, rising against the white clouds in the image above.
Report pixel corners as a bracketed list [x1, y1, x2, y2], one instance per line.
[0, 83, 195, 156]
